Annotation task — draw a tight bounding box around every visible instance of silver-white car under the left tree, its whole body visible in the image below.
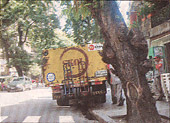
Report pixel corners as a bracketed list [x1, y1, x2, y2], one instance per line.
[7, 76, 32, 92]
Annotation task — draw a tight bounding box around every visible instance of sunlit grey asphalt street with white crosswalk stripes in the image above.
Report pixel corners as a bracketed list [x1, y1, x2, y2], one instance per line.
[0, 87, 97, 123]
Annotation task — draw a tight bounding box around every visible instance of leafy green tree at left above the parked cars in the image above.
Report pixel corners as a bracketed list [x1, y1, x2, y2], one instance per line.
[0, 0, 59, 76]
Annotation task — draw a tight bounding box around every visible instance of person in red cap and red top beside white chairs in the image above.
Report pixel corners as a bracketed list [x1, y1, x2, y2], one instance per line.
[153, 55, 164, 100]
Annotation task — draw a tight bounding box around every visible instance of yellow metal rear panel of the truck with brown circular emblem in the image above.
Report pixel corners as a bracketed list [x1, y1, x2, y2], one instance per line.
[44, 46, 106, 84]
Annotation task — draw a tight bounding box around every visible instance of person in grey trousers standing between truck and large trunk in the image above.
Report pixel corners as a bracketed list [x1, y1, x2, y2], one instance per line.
[107, 64, 125, 106]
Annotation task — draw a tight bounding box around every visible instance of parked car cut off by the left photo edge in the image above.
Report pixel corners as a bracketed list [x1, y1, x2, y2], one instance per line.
[0, 76, 12, 91]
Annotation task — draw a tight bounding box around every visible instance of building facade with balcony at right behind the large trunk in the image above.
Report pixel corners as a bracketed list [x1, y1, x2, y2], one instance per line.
[129, 1, 170, 73]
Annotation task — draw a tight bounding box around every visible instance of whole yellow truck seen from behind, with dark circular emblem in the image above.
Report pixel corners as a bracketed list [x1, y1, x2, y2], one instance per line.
[42, 44, 107, 106]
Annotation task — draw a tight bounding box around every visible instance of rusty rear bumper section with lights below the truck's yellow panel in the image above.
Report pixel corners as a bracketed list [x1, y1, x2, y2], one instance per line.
[51, 82, 107, 100]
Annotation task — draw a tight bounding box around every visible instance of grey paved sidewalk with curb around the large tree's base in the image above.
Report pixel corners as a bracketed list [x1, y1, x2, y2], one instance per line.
[90, 88, 170, 123]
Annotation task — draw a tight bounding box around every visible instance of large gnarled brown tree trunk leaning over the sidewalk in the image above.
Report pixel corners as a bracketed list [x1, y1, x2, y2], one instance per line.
[89, 1, 161, 123]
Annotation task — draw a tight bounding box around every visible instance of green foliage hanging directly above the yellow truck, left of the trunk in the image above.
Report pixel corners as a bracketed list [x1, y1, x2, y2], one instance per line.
[61, 1, 104, 44]
